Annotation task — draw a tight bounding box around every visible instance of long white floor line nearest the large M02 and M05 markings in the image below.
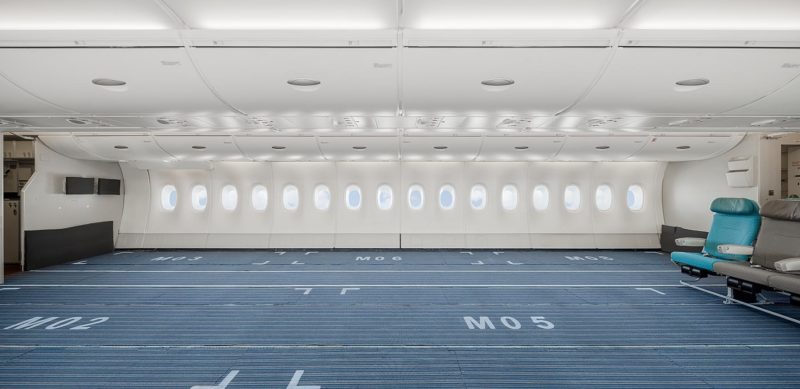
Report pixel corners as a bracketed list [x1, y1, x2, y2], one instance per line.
[7, 284, 726, 289]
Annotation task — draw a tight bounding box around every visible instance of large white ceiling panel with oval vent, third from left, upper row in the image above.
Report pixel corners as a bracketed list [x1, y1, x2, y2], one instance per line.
[403, 48, 610, 116]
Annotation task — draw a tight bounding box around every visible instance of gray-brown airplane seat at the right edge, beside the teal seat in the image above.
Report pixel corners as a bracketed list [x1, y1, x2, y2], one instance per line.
[714, 200, 800, 303]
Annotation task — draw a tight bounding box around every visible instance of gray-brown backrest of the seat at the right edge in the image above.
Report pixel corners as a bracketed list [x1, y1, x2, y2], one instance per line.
[751, 200, 800, 269]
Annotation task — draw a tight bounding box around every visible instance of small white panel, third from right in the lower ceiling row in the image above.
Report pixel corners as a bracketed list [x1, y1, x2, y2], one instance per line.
[476, 136, 566, 161]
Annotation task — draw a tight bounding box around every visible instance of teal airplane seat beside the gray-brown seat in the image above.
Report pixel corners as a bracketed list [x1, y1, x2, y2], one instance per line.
[671, 197, 761, 277]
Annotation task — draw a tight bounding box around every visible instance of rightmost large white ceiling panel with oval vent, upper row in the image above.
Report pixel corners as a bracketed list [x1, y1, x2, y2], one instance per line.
[569, 48, 800, 116]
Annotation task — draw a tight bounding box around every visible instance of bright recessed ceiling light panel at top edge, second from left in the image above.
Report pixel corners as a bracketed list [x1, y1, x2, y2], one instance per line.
[165, 0, 398, 30]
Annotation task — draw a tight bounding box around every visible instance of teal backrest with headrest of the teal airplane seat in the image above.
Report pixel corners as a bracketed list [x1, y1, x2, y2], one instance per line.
[703, 197, 761, 261]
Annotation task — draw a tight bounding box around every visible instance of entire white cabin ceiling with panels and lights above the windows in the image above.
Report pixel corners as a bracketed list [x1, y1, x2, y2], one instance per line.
[0, 0, 800, 162]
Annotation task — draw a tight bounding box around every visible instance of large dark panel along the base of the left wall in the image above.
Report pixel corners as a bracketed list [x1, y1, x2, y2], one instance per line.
[25, 221, 114, 270]
